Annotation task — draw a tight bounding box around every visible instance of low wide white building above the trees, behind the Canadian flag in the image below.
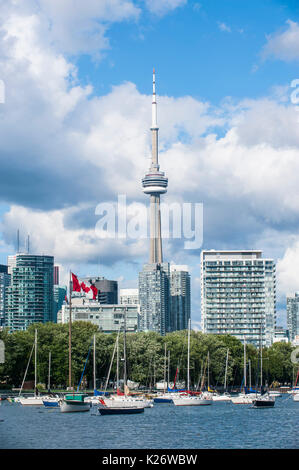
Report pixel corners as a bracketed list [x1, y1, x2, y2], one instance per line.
[57, 296, 140, 333]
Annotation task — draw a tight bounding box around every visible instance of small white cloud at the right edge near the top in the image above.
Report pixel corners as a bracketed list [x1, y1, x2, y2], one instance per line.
[262, 20, 299, 62]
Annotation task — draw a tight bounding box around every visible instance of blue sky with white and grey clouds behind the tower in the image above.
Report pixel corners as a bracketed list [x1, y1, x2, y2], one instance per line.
[0, 0, 299, 328]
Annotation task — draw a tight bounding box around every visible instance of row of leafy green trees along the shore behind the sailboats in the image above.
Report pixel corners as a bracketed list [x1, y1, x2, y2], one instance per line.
[0, 321, 297, 389]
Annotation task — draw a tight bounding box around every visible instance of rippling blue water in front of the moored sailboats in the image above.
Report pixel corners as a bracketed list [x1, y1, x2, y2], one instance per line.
[0, 395, 299, 449]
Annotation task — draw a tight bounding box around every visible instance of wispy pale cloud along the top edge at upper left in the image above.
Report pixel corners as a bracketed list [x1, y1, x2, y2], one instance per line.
[0, 0, 141, 57]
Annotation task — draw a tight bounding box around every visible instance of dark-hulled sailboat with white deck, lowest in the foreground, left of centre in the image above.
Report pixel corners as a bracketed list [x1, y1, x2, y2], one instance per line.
[98, 313, 149, 415]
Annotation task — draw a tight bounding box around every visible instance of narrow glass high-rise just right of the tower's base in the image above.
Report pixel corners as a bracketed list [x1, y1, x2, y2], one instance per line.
[169, 265, 191, 331]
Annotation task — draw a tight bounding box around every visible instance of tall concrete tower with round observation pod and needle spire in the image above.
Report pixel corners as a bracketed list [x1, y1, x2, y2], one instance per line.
[142, 69, 168, 264]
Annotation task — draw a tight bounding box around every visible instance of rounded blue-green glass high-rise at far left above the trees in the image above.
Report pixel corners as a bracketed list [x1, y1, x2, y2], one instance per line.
[6, 253, 54, 331]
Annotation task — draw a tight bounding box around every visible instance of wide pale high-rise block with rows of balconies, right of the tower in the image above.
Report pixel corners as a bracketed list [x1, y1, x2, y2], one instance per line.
[201, 250, 276, 347]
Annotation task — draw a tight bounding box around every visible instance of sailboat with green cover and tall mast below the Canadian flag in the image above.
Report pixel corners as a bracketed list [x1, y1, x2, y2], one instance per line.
[60, 272, 90, 413]
